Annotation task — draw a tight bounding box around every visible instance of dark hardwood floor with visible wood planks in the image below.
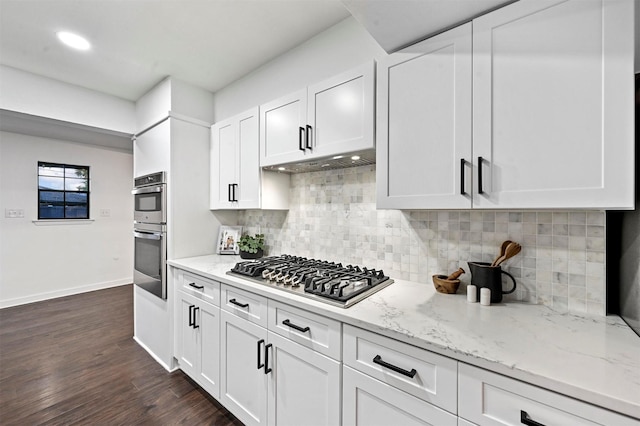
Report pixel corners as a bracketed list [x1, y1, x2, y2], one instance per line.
[0, 285, 242, 426]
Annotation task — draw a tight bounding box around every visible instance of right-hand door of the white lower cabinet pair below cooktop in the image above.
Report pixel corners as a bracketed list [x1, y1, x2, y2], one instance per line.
[268, 332, 341, 426]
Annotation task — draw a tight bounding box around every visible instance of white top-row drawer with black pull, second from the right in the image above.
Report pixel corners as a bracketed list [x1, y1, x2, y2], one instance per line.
[343, 325, 458, 413]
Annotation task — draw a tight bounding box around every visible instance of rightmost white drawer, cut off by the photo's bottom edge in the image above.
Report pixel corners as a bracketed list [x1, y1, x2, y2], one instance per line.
[458, 363, 640, 426]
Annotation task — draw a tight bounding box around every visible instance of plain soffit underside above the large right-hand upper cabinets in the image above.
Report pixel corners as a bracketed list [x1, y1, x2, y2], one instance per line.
[342, 0, 516, 53]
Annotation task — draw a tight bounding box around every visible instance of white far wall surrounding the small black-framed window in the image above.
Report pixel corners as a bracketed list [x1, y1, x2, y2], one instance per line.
[0, 132, 133, 307]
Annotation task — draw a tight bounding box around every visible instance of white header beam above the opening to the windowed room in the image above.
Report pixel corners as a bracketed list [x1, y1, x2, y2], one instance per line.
[0, 65, 136, 134]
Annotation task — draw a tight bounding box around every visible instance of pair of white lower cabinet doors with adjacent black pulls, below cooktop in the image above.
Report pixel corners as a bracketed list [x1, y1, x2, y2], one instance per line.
[220, 301, 341, 426]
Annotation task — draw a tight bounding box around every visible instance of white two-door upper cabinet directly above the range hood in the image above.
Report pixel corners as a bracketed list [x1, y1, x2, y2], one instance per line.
[260, 62, 375, 167]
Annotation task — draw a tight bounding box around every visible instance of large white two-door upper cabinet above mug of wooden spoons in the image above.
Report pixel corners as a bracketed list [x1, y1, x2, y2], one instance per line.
[377, 0, 634, 209]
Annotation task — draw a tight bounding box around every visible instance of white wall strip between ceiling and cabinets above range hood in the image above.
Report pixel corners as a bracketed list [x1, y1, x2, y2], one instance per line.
[214, 18, 387, 121]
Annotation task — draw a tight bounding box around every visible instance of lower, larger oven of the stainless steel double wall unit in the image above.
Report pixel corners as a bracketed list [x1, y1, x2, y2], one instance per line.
[133, 223, 167, 299]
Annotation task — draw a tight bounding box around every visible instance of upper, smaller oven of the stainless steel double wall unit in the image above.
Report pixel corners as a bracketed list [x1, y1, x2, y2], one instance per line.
[131, 172, 167, 223]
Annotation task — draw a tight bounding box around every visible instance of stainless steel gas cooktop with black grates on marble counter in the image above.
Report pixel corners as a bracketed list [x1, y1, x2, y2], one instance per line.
[227, 254, 393, 308]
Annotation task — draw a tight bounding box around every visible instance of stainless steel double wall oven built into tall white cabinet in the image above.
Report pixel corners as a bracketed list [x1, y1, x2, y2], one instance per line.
[131, 172, 167, 299]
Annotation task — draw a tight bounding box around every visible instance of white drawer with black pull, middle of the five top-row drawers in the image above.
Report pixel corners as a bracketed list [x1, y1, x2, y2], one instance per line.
[268, 300, 342, 361]
